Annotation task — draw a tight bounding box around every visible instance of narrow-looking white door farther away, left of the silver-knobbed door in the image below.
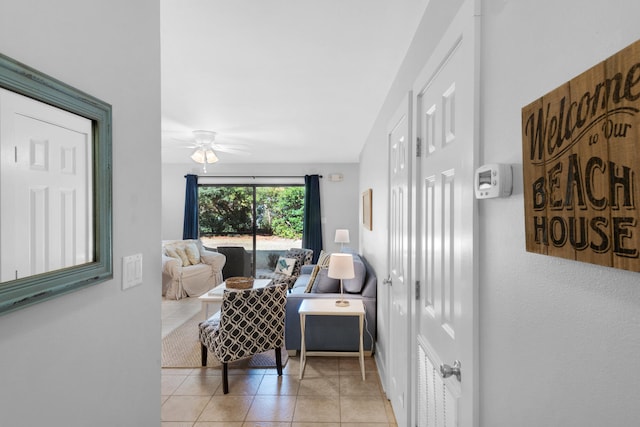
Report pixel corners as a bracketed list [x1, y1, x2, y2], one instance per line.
[387, 95, 411, 426]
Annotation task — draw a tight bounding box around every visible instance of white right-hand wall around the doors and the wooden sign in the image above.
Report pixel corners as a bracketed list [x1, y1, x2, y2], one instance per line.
[360, 0, 640, 427]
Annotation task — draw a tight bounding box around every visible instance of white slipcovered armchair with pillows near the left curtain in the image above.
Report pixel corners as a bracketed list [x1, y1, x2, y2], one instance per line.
[162, 240, 226, 299]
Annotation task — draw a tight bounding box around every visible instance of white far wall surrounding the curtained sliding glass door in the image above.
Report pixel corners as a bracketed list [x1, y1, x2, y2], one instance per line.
[162, 161, 360, 252]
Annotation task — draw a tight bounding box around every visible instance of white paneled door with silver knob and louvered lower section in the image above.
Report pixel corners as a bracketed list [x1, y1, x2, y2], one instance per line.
[413, 2, 477, 427]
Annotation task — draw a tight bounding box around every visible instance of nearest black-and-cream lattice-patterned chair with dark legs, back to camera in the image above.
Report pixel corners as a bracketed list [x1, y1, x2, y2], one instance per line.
[199, 283, 287, 394]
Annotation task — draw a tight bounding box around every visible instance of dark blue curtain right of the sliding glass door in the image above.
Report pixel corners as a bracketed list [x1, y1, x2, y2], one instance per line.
[302, 175, 322, 264]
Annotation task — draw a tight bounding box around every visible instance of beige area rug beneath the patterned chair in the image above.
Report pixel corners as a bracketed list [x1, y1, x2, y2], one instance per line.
[162, 312, 289, 368]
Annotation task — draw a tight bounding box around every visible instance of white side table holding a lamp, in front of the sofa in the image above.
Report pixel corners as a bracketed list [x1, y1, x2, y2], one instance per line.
[298, 299, 365, 381]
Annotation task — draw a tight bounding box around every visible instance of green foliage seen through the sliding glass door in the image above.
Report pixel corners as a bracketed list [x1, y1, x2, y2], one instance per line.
[198, 187, 304, 239]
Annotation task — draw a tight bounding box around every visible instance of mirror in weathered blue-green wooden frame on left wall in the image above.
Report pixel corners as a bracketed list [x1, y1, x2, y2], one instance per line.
[0, 54, 113, 314]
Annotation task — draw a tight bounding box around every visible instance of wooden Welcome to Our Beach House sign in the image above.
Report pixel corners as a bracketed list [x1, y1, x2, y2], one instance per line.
[522, 41, 640, 271]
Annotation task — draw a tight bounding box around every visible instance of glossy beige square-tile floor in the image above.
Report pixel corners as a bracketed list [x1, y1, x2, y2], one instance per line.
[161, 298, 397, 427]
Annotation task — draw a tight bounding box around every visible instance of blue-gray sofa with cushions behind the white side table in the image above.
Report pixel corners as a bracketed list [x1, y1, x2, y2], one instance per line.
[285, 255, 378, 356]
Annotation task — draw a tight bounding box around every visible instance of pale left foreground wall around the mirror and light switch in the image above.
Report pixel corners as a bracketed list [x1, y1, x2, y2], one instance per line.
[0, 0, 161, 427]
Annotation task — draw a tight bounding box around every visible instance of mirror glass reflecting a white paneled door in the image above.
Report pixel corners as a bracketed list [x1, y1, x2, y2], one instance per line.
[0, 89, 93, 282]
